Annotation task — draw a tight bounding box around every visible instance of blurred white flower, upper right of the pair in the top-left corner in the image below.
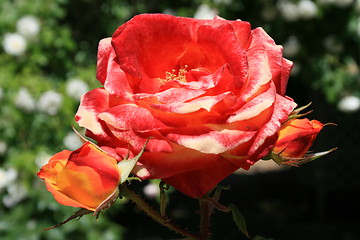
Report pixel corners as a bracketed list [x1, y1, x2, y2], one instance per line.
[16, 15, 40, 39]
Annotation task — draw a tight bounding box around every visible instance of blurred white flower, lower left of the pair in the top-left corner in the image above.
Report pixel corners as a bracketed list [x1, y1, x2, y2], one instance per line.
[3, 33, 27, 56]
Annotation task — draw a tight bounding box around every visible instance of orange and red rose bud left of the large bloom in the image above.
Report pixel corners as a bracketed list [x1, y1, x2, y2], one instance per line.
[37, 142, 121, 211]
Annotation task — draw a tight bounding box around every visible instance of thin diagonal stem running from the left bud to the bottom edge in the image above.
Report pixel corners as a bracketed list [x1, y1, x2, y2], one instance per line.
[119, 184, 200, 240]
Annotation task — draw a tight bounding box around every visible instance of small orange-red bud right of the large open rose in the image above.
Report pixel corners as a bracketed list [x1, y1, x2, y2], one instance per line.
[273, 118, 324, 158]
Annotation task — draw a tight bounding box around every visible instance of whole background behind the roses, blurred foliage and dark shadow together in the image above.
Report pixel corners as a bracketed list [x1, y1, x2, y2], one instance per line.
[0, 0, 360, 240]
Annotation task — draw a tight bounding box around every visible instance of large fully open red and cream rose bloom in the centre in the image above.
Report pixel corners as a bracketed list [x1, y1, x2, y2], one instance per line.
[76, 14, 296, 198]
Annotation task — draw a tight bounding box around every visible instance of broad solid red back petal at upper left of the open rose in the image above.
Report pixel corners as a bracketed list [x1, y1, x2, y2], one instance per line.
[112, 14, 191, 93]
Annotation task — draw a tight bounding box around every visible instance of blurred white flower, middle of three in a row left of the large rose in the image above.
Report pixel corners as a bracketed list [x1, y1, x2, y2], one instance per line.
[38, 90, 62, 116]
